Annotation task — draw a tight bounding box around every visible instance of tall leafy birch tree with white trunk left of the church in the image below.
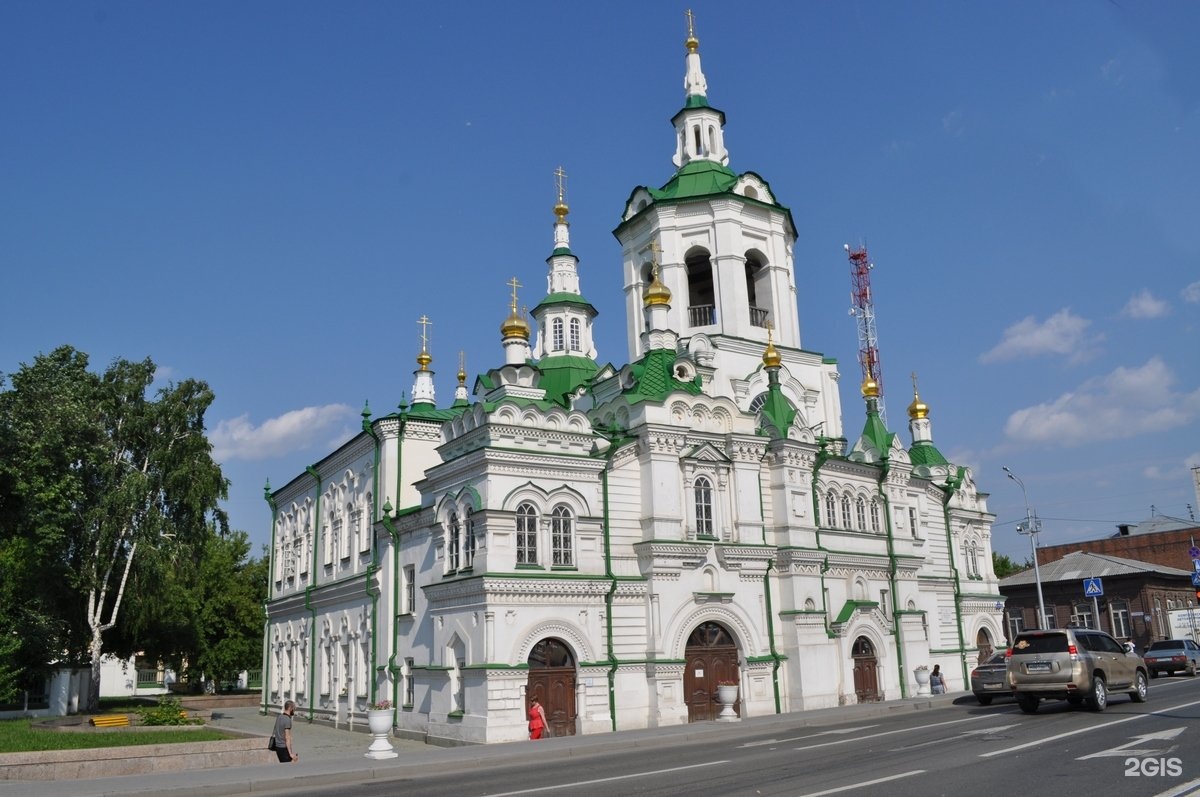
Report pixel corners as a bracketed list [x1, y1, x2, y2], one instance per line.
[0, 346, 228, 709]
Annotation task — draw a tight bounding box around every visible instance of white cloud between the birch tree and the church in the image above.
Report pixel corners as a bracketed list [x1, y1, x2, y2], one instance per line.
[209, 405, 355, 462]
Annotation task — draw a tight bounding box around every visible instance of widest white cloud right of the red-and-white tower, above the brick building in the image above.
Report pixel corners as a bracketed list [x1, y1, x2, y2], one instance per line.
[1004, 356, 1200, 445]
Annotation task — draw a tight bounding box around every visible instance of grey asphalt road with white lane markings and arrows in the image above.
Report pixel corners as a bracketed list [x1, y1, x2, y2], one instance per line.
[288, 677, 1200, 797]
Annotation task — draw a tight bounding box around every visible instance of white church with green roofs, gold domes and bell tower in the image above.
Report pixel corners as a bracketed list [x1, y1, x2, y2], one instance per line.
[263, 18, 1003, 743]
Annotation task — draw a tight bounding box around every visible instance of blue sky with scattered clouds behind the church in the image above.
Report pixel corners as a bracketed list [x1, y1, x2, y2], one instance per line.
[0, 0, 1200, 567]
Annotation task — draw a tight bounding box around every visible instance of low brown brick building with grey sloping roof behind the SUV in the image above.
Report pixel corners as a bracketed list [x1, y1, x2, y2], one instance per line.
[1000, 552, 1195, 651]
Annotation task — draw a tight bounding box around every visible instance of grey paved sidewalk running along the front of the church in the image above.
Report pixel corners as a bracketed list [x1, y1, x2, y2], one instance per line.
[0, 693, 955, 797]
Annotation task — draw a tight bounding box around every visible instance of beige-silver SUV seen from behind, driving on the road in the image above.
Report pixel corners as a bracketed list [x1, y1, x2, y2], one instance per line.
[1008, 628, 1150, 714]
